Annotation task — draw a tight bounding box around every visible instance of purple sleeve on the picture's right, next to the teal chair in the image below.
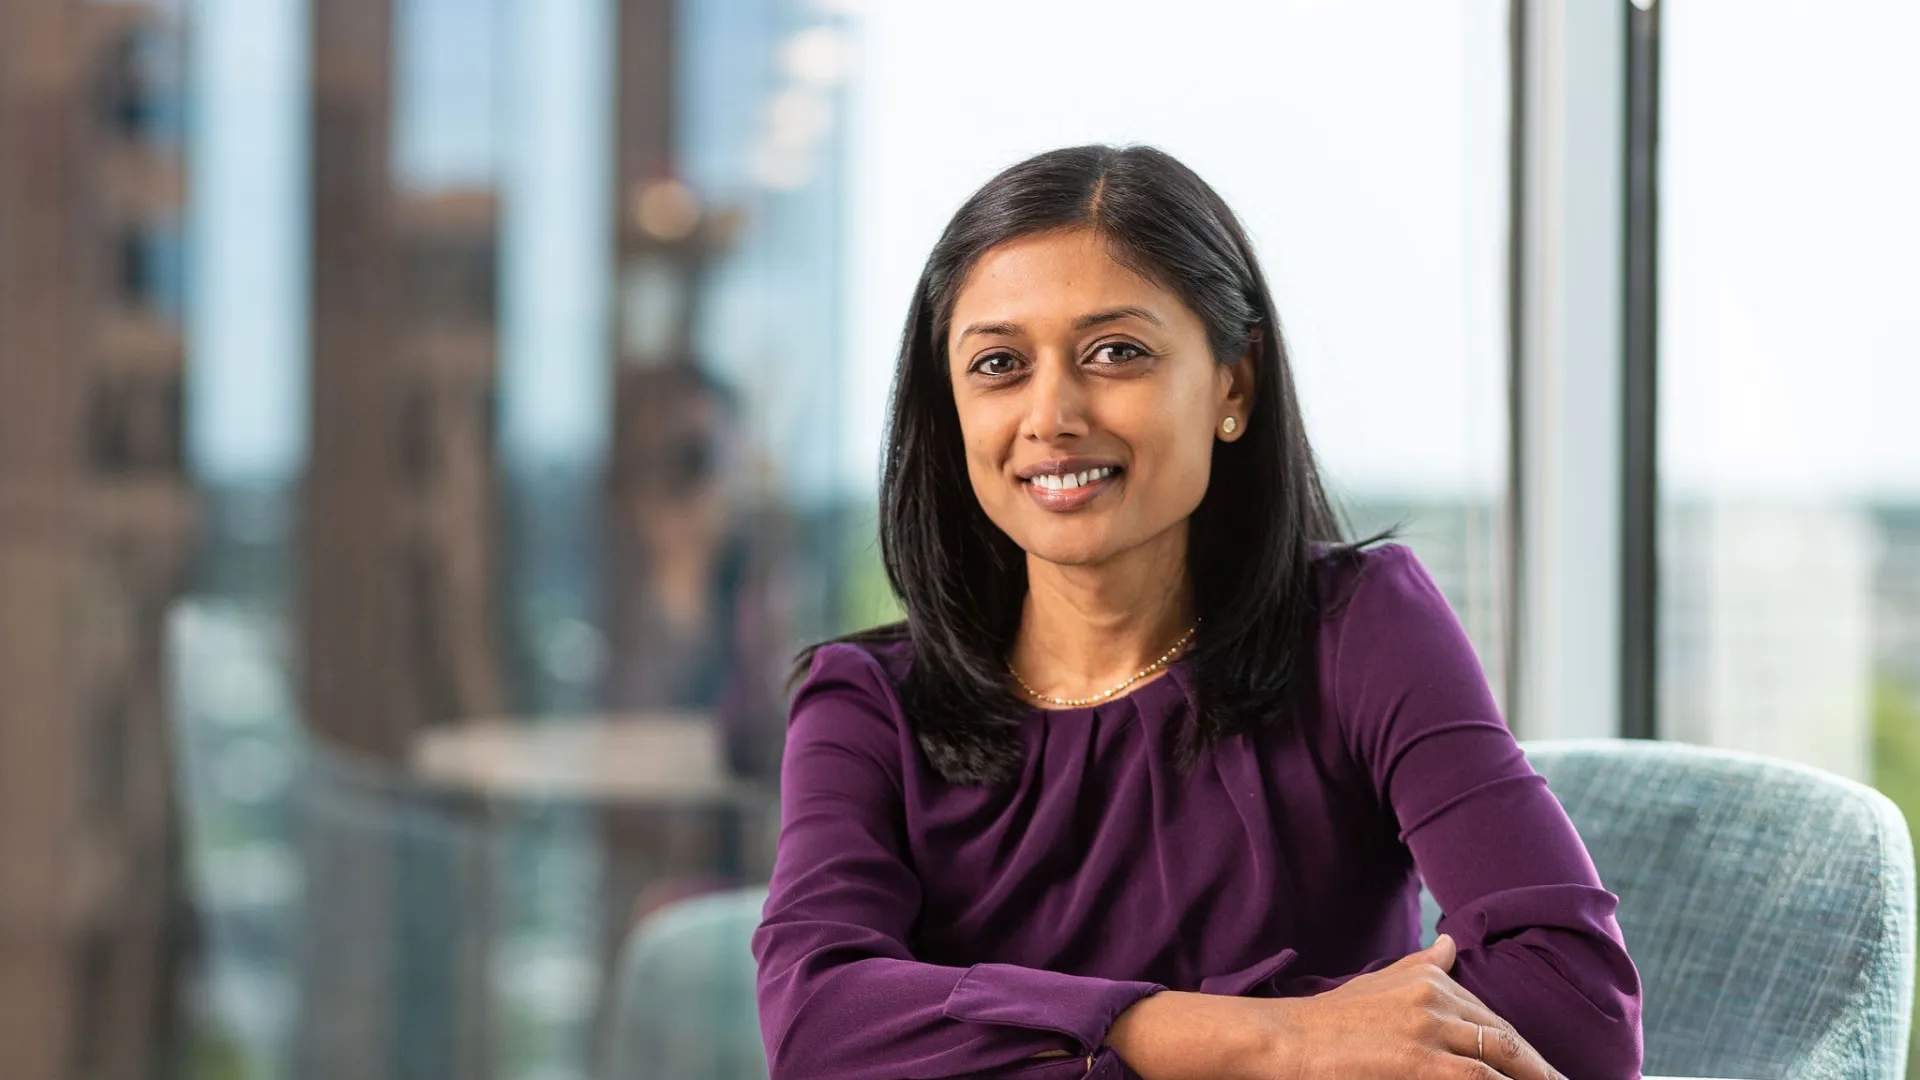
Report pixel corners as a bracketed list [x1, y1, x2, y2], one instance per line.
[1331, 546, 1642, 1080]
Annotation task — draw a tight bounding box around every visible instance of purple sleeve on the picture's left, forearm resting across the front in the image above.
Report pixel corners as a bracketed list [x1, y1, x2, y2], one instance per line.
[753, 646, 1164, 1080]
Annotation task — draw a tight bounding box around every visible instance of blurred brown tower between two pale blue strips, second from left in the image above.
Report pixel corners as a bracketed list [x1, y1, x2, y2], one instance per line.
[305, 0, 501, 763]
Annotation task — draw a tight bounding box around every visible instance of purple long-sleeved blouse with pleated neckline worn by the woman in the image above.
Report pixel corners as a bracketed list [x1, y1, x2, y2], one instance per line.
[753, 544, 1642, 1080]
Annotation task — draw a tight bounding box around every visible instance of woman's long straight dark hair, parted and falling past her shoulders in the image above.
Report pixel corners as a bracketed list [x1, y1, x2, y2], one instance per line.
[795, 146, 1394, 784]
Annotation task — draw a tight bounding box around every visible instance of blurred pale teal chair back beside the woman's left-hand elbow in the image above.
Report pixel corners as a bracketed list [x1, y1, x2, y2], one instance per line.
[603, 886, 766, 1080]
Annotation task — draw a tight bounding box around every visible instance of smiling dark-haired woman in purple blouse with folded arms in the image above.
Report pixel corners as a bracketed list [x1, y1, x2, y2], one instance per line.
[753, 146, 1642, 1080]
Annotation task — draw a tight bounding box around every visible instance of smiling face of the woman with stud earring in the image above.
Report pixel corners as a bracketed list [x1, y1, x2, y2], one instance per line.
[947, 229, 1252, 565]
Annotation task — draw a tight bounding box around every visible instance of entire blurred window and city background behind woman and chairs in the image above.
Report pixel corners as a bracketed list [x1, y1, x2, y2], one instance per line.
[0, 0, 1920, 1080]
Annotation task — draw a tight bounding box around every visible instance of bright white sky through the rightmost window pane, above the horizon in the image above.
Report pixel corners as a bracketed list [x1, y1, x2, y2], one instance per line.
[1659, 0, 1920, 498]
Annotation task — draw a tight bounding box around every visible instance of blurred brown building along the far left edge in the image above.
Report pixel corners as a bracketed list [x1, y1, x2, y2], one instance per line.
[0, 0, 194, 1080]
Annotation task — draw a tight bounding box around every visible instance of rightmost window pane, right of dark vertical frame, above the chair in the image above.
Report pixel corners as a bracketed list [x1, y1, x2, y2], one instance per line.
[1659, 0, 1920, 791]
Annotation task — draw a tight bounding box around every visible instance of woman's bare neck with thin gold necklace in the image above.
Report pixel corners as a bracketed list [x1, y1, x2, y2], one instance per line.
[1010, 530, 1194, 698]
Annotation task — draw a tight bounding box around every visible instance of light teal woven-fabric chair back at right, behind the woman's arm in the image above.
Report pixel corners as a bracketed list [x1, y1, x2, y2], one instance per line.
[1421, 740, 1914, 1080]
